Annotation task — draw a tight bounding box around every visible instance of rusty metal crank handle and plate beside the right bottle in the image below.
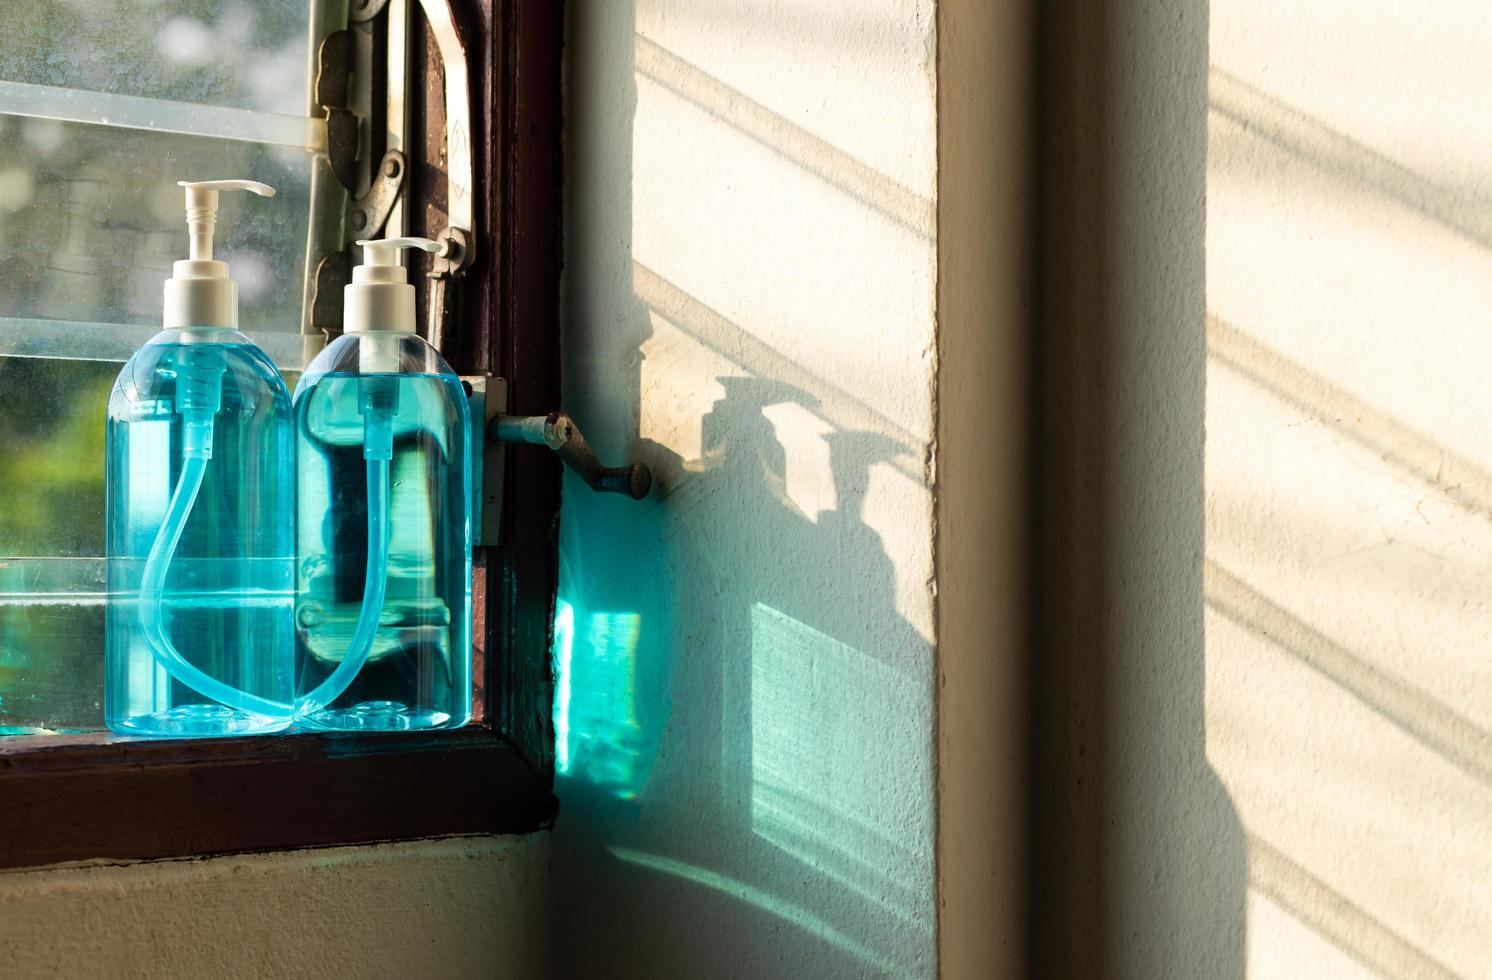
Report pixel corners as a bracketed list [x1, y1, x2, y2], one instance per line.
[461, 377, 652, 546]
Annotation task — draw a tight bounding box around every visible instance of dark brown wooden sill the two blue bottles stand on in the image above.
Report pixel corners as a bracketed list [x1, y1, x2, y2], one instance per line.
[0, 725, 557, 868]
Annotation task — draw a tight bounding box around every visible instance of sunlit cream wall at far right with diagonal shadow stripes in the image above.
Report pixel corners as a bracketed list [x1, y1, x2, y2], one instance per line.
[1198, 0, 1492, 977]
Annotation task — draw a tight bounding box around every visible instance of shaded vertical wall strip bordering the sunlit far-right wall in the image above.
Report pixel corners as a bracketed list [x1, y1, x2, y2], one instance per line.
[1031, 0, 1247, 979]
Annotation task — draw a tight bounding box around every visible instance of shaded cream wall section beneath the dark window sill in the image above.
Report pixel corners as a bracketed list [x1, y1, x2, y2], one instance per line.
[0, 834, 551, 980]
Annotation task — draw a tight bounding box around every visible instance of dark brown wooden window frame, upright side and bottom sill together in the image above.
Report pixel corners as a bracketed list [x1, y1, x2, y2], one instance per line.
[0, 0, 562, 868]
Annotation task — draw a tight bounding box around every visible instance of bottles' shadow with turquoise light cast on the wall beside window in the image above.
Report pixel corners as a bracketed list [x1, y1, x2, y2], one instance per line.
[554, 357, 935, 976]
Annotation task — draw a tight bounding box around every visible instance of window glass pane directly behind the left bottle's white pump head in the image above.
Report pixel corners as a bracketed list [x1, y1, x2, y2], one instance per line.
[0, 117, 310, 338]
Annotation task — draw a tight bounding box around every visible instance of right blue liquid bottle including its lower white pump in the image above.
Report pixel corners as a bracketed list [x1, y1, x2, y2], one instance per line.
[295, 239, 471, 731]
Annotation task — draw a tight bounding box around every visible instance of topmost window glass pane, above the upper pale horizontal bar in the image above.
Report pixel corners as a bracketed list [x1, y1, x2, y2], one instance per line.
[0, 0, 309, 115]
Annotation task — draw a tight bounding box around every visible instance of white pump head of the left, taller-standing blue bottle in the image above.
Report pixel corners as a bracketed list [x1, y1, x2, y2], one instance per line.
[166, 180, 275, 330]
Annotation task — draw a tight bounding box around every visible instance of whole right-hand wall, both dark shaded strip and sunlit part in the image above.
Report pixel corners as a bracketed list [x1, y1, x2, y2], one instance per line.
[1032, 0, 1492, 979]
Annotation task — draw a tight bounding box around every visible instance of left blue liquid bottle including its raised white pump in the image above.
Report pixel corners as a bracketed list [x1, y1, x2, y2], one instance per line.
[104, 180, 295, 737]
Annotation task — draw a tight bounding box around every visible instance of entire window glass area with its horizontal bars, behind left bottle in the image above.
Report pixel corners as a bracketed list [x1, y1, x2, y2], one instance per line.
[0, 0, 323, 734]
